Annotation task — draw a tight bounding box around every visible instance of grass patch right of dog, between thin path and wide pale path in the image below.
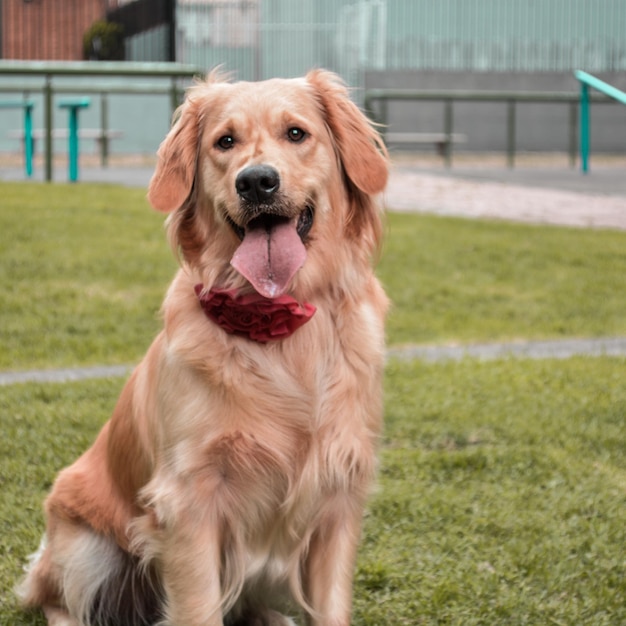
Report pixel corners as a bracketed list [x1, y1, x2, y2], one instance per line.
[379, 214, 626, 343]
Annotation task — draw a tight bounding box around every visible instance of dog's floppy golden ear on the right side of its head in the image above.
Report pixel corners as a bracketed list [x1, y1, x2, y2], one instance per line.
[306, 70, 388, 194]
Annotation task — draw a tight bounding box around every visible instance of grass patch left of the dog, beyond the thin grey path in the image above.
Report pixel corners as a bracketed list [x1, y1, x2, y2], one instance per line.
[0, 183, 176, 370]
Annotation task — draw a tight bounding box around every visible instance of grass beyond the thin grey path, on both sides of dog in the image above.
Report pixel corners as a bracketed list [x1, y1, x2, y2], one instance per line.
[0, 178, 626, 370]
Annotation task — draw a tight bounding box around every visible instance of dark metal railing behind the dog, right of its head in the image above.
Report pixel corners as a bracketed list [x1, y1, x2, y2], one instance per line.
[364, 89, 610, 168]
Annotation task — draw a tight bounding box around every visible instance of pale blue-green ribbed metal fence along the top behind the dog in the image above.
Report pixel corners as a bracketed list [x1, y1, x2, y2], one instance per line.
[176, 0, 626, 83]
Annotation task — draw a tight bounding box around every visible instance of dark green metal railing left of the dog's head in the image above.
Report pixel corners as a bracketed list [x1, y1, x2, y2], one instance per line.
[0, 61, 201, 181]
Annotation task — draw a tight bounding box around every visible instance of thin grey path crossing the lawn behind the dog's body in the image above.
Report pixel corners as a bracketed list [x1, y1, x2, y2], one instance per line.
[0, 337, 626, 387]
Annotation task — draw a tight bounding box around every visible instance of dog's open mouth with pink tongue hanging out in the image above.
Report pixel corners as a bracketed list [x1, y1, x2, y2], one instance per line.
[227, 205, 315, 298]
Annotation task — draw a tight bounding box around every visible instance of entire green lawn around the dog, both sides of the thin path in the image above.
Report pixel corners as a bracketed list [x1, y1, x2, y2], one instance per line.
[0, 178, 626, 626]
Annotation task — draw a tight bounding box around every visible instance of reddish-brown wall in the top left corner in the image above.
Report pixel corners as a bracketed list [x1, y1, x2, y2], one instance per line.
[0, 0, 107, 61]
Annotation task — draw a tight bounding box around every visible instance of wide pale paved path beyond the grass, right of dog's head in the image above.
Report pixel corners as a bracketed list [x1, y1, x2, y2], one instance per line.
[385, 165, 626, 230]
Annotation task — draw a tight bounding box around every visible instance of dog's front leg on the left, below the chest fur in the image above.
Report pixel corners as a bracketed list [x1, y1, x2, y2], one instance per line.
[160, 516, 223, 626]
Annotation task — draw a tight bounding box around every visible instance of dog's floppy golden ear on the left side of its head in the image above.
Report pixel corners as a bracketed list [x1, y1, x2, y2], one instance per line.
[148, 97, 200, 213]
